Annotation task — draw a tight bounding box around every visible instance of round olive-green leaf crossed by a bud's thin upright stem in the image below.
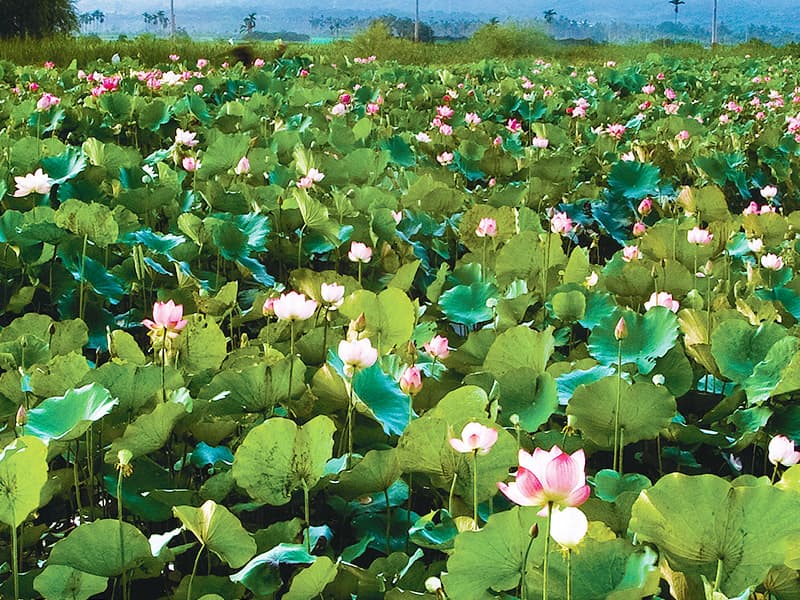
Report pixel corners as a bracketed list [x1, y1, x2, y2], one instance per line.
[567, 376, 677, 448]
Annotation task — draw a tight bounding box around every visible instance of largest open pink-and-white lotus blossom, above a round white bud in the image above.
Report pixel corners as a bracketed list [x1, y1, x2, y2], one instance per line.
[497, 446, 590, 515]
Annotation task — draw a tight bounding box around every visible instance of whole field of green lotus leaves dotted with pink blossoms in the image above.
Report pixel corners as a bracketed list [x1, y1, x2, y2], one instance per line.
[0, 55, 800, 600]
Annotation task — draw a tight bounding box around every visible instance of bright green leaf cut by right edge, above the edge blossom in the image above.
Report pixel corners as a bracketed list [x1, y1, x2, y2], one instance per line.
[742, 336, 800, 404]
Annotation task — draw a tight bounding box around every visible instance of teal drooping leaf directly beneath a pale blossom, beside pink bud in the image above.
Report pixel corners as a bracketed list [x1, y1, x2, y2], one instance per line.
[353, 363, 413, 435]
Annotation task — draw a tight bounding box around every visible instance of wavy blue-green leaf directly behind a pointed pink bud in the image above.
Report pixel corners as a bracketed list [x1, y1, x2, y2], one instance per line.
[588, 306, 678, 375]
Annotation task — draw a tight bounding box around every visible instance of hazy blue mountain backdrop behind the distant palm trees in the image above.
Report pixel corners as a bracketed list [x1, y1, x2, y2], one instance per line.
[72, 0, 800, 37]
